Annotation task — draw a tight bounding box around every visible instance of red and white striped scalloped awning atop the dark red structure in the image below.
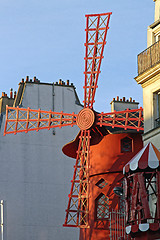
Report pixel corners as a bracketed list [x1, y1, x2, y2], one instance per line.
[123, 143, 160, 174]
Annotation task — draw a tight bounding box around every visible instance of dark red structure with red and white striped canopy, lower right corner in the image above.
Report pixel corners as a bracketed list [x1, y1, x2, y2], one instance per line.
[124, 143, 160, 240]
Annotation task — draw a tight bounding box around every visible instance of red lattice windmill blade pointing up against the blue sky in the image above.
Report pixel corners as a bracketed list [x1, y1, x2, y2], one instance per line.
[84, 13, 112, 108]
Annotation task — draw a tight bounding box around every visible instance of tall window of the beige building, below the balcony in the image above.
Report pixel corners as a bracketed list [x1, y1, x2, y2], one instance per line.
[154, 91, 160, 127]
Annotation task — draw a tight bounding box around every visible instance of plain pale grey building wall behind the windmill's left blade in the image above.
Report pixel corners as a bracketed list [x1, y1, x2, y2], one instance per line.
[0, 83, 81, 240]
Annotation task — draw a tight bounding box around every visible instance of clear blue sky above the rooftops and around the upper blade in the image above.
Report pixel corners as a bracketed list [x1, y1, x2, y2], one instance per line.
[0, 0, 154, 112]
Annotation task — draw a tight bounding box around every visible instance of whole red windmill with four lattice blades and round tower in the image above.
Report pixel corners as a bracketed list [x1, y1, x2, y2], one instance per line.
[4, 13, 143, 240]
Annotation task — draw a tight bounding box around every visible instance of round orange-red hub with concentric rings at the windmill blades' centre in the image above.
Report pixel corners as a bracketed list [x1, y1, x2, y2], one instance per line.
[77, 108, 95, 130]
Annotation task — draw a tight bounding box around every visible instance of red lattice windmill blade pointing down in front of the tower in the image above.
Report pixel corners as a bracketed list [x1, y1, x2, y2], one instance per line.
[63, 130, 90, 228]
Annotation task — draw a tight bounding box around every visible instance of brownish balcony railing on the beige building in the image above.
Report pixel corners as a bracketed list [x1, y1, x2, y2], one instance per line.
[138, 41, 160, 75]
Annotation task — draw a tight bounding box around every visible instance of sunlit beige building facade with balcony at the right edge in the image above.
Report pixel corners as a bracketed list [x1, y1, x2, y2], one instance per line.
[135, 0, 160, 150]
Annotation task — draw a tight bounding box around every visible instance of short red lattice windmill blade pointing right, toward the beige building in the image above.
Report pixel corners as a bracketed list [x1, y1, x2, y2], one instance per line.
[96, 108, 144, 131]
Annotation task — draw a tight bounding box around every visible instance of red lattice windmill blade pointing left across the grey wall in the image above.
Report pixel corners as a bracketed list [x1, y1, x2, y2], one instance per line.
[4, 106, 77, 136]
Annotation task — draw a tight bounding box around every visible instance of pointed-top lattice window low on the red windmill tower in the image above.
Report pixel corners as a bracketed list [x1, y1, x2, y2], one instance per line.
[96, 193, 109, 220]
